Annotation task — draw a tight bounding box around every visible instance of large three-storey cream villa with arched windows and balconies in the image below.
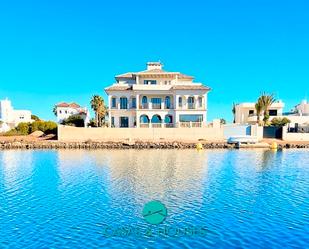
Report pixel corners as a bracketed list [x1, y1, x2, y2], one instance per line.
[105, 62, 210, 128]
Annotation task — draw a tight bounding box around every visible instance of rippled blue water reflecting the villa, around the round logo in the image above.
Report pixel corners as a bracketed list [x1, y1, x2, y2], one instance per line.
[0, 150, 309, 249]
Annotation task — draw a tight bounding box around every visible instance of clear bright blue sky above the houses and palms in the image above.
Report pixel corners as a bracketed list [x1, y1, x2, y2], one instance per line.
[0, 0, 309, 120]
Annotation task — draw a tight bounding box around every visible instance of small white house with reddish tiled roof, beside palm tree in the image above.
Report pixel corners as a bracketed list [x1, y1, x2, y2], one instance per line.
[56, 102, 90, 126]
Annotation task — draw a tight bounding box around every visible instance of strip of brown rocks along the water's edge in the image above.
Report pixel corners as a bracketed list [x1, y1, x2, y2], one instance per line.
[0, 141, 309, 150]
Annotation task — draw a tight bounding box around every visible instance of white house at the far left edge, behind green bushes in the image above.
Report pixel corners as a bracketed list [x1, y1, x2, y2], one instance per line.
[0, 99, 33, 132]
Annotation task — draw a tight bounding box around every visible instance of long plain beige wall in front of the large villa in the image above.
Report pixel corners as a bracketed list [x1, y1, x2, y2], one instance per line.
[58, 125, 224, 142]
